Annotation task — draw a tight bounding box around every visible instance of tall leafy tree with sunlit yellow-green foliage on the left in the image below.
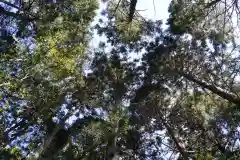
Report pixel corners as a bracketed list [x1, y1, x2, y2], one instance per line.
[1, 1, 97, 158]
